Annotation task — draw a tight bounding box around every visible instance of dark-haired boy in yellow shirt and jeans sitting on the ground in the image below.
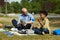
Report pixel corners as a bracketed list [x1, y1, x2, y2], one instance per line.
[32, 11, 50, 34]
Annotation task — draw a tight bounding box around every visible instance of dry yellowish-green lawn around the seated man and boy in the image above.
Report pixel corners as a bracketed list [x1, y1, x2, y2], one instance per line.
[0, 17, 60, 40]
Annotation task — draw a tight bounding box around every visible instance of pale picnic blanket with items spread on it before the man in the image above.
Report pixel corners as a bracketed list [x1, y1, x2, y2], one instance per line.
[4, 28, 36, 36]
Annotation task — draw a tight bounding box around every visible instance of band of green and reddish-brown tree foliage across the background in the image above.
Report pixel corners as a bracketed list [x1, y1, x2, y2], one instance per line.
[2, 0, 60, 14]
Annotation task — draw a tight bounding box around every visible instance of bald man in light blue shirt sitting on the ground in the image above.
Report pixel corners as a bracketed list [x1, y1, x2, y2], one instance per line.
[12, 8, 34, 30]
